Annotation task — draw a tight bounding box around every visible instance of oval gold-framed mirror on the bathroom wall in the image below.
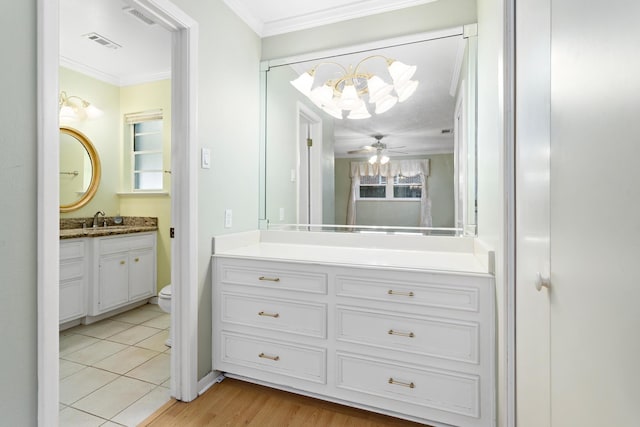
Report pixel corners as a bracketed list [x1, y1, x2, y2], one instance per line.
[60, 126, 100, 212]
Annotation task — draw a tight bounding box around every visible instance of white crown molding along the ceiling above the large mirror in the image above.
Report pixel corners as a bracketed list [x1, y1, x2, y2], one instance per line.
[224, 0, 438, 37]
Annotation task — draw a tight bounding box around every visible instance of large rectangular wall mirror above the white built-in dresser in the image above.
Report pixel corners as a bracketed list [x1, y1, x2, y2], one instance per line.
[260, 25, 477, 235]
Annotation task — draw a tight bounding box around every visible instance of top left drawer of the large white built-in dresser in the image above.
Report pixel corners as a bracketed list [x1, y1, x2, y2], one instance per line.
[217, 261, 327, 294]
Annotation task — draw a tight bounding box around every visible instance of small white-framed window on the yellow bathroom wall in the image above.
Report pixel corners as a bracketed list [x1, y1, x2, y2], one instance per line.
[125, 110, 164, 191]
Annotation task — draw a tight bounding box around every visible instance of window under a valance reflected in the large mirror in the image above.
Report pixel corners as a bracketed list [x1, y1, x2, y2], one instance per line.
[358, 175, 422, 200]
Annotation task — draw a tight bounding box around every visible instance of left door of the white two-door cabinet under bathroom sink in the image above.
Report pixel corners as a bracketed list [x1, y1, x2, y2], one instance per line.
[98, 252, 129, 312]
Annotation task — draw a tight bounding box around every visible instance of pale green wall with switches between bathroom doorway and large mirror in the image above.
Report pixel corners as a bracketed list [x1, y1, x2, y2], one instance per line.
[173, 0, 260, 377]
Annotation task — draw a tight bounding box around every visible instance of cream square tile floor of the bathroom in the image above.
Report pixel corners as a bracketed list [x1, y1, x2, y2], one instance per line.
[60, 304, 171, 427]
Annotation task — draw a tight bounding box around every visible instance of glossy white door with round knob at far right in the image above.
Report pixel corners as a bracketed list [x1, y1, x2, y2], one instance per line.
[516, 0, 640, 427]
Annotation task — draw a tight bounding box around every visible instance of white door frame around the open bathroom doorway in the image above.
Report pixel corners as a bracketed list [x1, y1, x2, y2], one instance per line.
[36, 0, 198, 426]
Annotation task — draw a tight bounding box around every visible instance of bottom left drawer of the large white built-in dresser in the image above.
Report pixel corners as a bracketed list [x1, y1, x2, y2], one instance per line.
[221, 332, 326, 384]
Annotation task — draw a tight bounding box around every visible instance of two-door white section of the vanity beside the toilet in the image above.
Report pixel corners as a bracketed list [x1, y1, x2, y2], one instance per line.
[88, 232, 156, 316]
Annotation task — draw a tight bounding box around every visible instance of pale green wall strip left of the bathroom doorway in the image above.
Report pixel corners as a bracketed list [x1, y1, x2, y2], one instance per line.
[0, 0, 37, 426]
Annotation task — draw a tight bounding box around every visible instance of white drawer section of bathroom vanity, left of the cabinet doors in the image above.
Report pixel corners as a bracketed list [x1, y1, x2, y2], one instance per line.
[59, 239, 89, 323]
